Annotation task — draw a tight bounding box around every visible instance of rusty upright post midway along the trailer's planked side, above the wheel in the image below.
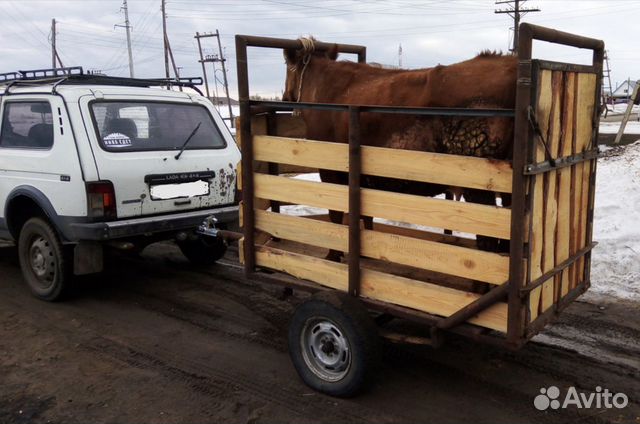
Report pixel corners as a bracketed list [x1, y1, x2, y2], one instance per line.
[349, 106, 362, 296]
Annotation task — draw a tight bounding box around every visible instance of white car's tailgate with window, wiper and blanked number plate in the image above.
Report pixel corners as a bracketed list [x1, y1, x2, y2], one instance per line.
[79, 95, 240, 218]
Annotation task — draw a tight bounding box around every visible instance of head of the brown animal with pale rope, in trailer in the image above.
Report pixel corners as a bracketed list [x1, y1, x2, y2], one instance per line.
[282, 37, 338, 102]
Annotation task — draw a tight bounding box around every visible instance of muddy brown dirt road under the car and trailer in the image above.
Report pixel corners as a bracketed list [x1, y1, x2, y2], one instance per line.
[0, 244, 640, 423]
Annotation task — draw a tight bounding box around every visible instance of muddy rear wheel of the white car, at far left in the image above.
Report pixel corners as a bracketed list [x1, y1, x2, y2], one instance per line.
[18, 218, 73, 302]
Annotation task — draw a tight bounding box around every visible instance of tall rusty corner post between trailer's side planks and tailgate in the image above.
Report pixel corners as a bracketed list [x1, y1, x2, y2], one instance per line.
[507, 24, 532, 345]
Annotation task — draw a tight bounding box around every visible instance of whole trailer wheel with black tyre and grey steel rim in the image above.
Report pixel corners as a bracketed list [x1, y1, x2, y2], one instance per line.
[289, 292, 380, 397]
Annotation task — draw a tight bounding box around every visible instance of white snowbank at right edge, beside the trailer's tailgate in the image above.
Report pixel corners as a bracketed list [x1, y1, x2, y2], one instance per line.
[591, 140, 640, 301]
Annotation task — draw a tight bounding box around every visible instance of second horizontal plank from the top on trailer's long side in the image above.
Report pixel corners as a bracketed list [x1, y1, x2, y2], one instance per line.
[254, 174, 511, 239]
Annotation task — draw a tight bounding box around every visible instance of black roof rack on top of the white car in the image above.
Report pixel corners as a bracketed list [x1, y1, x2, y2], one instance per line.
[0, 66, 202, 94]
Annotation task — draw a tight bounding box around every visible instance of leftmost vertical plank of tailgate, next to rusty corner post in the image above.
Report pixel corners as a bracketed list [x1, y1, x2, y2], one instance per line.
[529, 70, 553, 321]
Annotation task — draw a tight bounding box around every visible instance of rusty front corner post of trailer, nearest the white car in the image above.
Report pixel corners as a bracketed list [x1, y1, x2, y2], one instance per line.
[236, 36, 256, 276]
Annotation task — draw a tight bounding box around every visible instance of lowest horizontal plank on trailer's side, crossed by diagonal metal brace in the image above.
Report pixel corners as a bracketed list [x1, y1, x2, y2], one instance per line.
[256, 246, 507, 332]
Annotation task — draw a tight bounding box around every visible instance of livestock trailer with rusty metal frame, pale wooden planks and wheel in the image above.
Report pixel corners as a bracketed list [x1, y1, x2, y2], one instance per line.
[236, 24, 604, 395]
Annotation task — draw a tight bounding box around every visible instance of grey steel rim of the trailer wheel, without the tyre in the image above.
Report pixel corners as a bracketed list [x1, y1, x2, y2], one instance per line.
[300, 318, 351, 382]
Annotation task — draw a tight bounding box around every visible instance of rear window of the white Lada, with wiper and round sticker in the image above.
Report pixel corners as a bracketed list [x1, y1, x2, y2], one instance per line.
[91, 101, 226, 152]
